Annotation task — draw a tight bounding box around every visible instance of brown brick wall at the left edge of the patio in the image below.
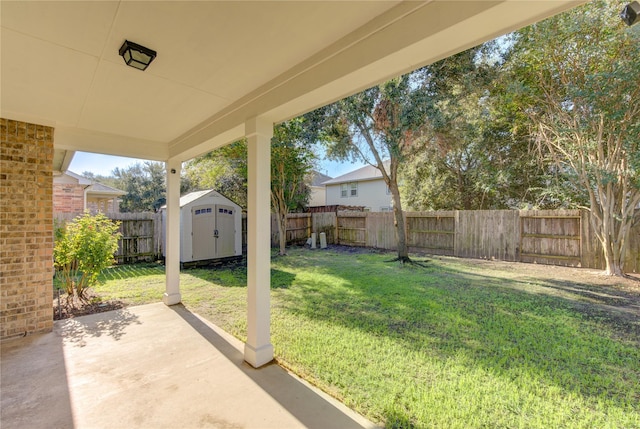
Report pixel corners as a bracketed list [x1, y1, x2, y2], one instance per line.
[0, 118, 53, 339]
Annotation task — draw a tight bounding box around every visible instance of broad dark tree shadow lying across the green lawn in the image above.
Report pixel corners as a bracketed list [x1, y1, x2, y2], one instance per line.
[282, 254, 640, 418]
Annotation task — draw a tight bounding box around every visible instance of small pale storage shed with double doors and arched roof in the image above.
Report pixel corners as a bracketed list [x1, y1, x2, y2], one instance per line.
[161, 190, 242, 262]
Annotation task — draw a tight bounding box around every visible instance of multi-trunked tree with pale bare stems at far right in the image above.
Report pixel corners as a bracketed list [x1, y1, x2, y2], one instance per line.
[509, 1, 640, 276]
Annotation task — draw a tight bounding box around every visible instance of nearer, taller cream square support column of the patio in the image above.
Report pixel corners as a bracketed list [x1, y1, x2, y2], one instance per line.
[244, 118, 273, 368]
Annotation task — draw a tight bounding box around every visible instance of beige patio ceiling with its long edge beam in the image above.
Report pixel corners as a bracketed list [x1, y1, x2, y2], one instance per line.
[0, 0, 582, 161]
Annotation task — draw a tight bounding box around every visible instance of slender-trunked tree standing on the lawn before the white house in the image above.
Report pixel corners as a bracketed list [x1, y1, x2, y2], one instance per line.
[327, 71, 427, 263]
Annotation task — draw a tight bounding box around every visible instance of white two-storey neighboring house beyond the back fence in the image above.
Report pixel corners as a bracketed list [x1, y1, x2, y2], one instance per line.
[323, 162, 393, 212]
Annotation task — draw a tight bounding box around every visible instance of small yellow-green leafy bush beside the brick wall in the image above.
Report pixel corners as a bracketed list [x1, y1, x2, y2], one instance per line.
[53, 212, 121, 300]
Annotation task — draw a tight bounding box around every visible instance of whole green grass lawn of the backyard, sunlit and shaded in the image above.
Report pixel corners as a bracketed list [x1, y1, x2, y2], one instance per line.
[91, 249, 640, 428]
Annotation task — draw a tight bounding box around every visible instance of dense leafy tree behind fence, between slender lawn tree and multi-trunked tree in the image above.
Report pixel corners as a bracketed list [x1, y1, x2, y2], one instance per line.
[401, 40, 542, 210]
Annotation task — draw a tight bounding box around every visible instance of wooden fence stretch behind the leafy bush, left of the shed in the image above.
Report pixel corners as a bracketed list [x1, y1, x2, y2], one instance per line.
[54, 212, 162, 264]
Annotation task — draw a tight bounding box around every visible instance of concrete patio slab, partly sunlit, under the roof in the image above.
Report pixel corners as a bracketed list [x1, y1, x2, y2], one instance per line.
[0, 303, 375, 429]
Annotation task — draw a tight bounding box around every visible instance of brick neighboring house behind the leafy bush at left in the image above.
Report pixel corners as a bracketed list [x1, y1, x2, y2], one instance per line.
[53, 171, 126, 214]
